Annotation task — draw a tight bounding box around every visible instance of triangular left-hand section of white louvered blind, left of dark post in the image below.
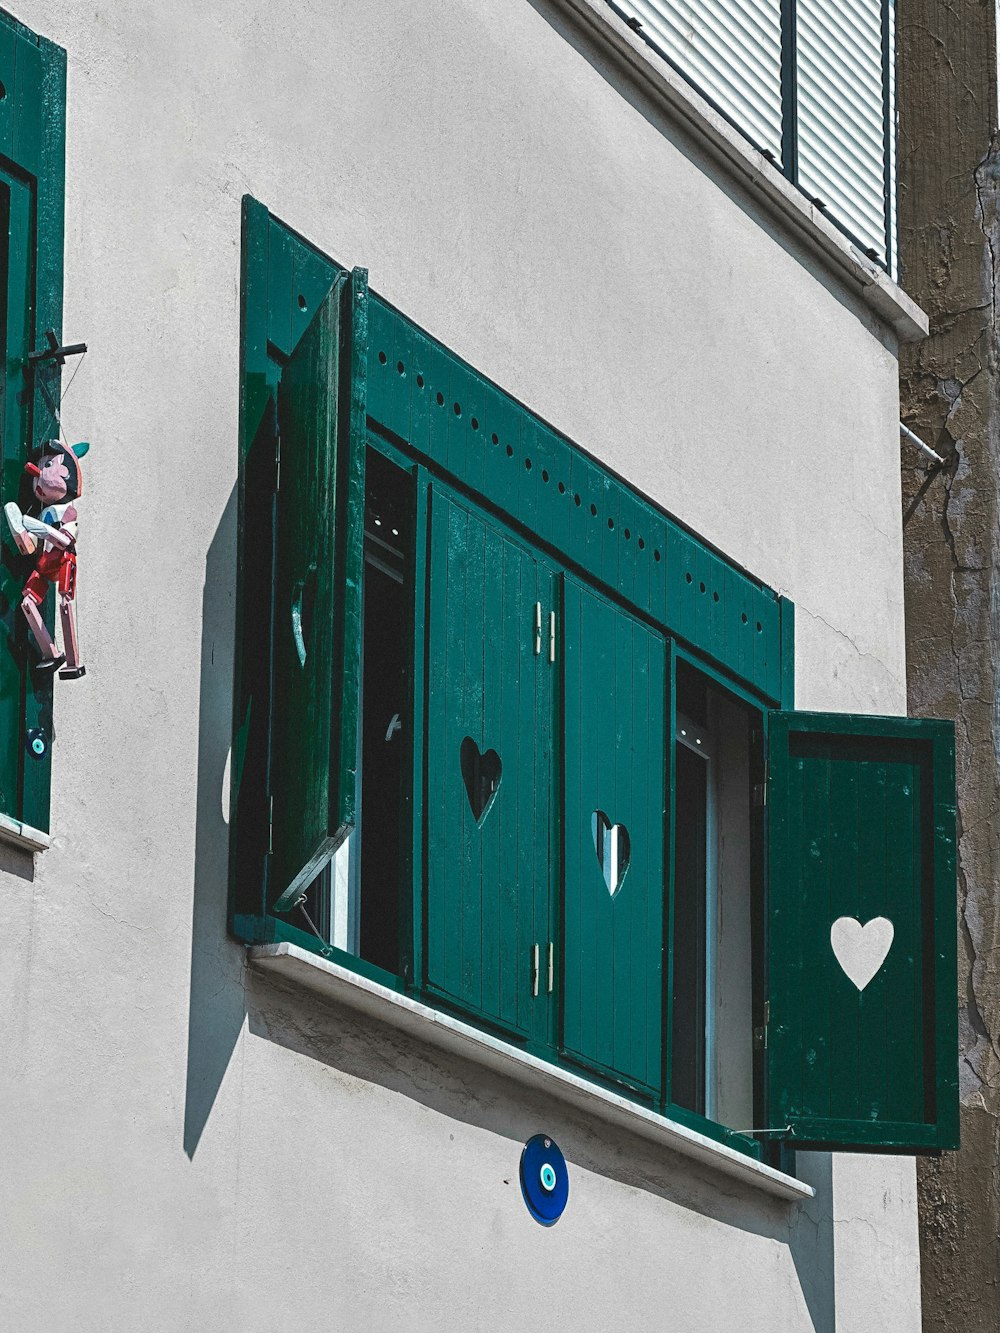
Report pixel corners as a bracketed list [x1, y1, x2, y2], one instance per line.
[616, 0, 781, 161]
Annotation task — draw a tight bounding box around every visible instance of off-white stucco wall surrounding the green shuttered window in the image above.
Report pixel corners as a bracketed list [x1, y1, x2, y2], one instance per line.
[0, 0, 919, 1333]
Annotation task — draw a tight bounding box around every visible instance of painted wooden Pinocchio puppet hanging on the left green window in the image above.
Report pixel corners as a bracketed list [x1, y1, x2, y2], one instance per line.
[4, 440, 89, 680]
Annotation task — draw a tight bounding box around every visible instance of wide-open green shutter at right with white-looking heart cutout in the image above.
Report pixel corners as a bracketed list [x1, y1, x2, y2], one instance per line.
[767, 713, 959, 1152]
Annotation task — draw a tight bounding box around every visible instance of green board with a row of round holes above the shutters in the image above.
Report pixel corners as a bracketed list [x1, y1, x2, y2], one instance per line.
[368, 297, 788, 702]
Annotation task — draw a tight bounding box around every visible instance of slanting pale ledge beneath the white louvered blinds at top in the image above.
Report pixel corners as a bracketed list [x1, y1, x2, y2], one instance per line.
[556, 0, 928, 343]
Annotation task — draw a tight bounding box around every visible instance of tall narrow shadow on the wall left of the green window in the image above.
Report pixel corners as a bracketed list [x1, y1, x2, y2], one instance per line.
[184, 488, 247, 1157]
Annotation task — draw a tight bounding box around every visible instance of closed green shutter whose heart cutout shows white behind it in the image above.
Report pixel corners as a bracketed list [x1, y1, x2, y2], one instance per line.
[563, 579, 667, 1090]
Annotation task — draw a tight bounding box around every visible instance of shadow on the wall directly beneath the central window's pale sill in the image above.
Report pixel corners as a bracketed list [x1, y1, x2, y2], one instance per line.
[245, 968, 836, 1333]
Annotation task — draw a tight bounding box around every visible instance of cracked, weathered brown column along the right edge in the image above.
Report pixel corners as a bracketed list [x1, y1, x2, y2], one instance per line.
[897, 0, 1000, 1333]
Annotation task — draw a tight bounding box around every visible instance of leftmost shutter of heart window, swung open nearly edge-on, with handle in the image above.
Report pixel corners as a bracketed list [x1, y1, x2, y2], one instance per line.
[268, 269, 368, 910]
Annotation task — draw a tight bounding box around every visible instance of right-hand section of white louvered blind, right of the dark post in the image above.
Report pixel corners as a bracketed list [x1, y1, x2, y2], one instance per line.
[796, 0, 895, 263]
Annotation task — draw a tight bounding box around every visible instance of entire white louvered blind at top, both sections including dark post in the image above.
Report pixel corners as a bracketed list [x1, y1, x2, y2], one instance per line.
[609, 0, 896, 275]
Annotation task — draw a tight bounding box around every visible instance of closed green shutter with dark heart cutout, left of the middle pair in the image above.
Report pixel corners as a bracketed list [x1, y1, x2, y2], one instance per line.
[425, 489, 556, 1037]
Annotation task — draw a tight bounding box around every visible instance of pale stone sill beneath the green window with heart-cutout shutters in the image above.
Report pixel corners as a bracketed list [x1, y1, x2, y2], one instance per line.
[248, 944, 815, 1201]
